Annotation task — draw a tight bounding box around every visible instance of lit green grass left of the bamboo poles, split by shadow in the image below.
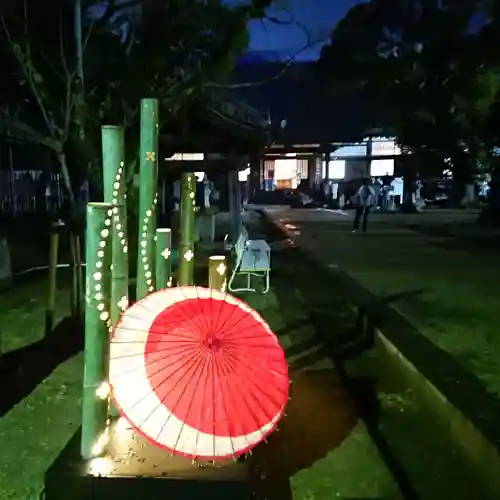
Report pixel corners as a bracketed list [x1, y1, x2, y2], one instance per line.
[0, 273, 78, 500]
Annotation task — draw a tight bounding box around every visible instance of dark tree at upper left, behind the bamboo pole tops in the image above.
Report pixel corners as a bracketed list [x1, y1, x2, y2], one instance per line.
[0, 0, 269, 211]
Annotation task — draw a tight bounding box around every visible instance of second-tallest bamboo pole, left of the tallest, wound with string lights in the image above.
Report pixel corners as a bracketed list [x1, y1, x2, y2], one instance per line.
[101, 126, 128, 325]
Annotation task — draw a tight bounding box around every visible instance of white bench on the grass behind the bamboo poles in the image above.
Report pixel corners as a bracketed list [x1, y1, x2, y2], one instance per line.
[228, 227, 271, 293]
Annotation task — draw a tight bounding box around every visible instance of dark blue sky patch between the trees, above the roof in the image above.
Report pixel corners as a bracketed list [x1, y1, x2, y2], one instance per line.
[250, 0, 361, 60]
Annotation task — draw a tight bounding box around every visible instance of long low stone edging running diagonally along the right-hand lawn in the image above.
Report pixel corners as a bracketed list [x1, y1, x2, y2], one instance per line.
[261, 211, 500, 498]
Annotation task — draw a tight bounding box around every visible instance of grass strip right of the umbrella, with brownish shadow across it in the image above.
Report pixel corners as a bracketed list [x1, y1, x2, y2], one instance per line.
[244, 283, 396, 500]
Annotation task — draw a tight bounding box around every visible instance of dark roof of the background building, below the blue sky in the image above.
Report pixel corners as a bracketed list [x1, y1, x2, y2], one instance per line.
[227, 61, 386, 144]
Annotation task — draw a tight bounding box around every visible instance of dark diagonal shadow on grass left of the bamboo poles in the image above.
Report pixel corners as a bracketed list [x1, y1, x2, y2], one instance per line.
[0, 318, 83, 417]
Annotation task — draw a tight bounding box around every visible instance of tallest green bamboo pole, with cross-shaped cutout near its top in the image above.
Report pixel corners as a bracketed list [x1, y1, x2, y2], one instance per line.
[136, 99, 158, 300]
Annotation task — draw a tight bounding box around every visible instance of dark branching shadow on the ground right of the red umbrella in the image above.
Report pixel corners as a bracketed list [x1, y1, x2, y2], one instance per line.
[248, 218, 423, 499]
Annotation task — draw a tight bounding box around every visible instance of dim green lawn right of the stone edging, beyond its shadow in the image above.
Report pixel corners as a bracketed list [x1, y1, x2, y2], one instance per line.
[276, 211, 500, 395]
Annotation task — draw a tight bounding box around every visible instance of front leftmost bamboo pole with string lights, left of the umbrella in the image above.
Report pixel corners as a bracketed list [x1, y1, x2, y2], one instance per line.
[80, 203, 113, 459]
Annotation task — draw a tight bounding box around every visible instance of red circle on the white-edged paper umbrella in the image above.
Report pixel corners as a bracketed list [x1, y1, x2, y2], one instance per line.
[144, 297, 289, 436]
